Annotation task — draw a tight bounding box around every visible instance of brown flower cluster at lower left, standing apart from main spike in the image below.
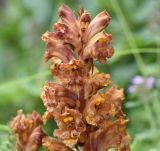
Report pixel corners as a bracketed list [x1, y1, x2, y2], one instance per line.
[10, 110, 45, 151]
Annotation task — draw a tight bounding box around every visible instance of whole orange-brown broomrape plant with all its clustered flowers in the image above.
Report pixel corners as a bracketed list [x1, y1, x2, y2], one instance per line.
[10, 5, 130, 151]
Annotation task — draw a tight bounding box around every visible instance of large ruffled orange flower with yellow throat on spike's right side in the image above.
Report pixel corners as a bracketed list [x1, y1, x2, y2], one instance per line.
[84, 86, 124, 128]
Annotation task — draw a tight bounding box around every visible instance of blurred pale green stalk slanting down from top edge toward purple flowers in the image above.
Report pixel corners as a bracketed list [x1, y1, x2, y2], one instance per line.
[110, 0, 146, 75]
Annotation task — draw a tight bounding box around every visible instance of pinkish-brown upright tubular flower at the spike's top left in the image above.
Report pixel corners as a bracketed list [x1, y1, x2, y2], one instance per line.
[54, 5, 82, 51]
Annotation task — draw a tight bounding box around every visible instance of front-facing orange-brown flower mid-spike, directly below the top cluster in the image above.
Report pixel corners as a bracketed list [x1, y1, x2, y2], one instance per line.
[52, 60, 89, 92]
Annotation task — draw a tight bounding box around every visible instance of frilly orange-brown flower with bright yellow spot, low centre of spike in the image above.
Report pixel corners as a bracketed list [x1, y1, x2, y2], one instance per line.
[54, 108, 86, 146]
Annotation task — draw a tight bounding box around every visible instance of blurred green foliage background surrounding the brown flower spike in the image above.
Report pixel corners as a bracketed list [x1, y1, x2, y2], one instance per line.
[0, 0, 160, 151]
